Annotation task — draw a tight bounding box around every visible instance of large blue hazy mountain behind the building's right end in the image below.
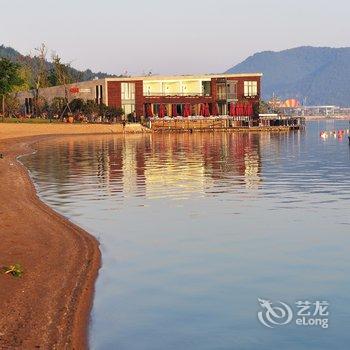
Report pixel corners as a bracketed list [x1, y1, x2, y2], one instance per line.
[227, 46, 350, 106]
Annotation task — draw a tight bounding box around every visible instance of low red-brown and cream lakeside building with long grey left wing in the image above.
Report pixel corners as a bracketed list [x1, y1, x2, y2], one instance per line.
[17, 73, 262, 117]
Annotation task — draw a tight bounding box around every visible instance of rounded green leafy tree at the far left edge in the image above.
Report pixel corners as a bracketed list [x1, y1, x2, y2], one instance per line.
[0, 58, 23, 117]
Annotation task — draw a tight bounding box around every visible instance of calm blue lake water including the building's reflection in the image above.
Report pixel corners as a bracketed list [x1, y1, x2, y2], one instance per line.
[22, 122, 350, 350]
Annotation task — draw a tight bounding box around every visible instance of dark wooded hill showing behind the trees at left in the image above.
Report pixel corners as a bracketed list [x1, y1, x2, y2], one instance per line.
[0, 45, 115, 82]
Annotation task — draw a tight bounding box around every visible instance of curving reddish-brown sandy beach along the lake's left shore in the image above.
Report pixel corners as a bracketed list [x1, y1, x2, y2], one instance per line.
[0, 124, 148, 349]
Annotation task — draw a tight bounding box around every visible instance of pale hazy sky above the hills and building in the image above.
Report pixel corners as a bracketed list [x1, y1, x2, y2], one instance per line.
[0, 0, 350, 74]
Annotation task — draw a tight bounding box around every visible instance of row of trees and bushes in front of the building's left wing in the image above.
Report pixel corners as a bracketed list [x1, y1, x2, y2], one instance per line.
[0, 44, 124, 120]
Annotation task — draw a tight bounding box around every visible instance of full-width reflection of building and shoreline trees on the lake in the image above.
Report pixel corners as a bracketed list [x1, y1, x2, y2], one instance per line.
[27, 132, 271, 197]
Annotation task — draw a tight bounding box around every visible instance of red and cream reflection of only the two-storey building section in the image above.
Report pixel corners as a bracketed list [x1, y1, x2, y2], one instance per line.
[103, 133, 261, 197]
